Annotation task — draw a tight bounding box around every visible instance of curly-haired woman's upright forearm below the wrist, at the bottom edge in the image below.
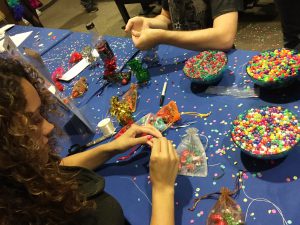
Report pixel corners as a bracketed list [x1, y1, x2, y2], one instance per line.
[151, 188, 175, 225]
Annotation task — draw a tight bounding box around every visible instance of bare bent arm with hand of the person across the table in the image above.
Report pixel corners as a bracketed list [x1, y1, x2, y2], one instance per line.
[132, 12, 238, 51]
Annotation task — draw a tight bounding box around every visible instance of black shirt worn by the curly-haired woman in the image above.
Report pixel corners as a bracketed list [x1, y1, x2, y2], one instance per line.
[61, 166, 126, 225]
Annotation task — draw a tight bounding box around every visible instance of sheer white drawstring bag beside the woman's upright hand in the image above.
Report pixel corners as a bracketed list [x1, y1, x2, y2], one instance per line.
[176, 127, 207, 177]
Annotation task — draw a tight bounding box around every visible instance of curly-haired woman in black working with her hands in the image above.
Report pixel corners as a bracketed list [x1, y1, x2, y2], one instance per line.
[0, 56, 178, 225]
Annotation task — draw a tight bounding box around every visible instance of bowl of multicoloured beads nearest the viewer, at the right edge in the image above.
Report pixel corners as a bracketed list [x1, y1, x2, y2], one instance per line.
[231, 106, 300, 159]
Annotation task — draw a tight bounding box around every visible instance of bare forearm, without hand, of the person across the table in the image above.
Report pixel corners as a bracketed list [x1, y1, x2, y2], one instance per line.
[158, 28, 233, 51]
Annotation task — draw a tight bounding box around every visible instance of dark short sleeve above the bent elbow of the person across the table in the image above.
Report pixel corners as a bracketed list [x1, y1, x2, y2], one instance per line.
[211, 0, 238, 19]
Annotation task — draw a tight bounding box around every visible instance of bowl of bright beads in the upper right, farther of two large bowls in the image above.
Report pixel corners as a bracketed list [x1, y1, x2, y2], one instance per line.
[246, 48, 300, 88]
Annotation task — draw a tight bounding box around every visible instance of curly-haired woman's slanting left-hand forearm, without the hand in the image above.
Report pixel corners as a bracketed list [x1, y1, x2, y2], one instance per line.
[61, 143, 116, 170]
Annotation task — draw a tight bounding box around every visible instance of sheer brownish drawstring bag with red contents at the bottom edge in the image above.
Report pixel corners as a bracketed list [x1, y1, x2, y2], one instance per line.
[206, 187, 245, 225]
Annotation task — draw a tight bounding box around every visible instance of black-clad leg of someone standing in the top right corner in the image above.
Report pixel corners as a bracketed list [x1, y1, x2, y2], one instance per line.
[274, 0, 300, 50]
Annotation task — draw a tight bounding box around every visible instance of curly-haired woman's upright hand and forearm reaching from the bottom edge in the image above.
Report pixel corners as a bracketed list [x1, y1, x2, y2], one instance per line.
[150, 138, 179, 225]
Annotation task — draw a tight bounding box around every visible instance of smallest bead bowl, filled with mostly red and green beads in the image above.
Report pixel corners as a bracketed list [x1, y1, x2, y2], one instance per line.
[183, 50, 227, 85]
